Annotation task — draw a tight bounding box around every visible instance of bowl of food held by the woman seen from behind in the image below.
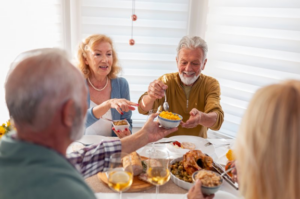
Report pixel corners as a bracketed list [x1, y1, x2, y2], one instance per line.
[192, 169, 223, 195]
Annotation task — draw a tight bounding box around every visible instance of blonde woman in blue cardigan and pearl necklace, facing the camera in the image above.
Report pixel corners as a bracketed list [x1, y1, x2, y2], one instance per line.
[77, 34, 137, 137]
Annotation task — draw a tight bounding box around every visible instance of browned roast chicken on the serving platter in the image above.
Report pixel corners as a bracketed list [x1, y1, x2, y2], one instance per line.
[183, 150, 213, 175]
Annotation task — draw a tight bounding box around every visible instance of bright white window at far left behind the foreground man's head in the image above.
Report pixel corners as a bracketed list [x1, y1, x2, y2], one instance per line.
[0, 0, 65, 124]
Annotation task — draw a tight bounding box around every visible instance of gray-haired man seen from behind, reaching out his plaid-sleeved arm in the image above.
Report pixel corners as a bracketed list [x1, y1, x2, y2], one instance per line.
[0, 49, 177, 199]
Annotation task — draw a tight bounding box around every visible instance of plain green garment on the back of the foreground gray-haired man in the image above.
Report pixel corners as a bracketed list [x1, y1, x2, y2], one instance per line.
[0, 132, 96, 199]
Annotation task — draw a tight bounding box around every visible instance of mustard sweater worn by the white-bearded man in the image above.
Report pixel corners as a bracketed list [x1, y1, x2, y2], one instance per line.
[138, 72, 224, 138]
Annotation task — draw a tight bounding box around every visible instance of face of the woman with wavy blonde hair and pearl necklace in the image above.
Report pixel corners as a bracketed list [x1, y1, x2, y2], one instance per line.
[85, 42, 113, 77]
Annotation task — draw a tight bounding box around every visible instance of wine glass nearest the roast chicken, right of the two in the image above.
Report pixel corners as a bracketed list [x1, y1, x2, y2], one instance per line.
[147, 148, 170, 198]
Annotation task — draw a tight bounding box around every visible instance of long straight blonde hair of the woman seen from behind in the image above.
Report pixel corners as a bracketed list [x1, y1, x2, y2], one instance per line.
[236, 80, 300, 199]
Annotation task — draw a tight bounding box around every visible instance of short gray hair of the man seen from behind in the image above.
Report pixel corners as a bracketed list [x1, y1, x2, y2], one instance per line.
[5, 49, 85, 131]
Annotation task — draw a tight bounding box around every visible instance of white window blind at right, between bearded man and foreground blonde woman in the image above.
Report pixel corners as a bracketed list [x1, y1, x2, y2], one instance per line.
[205, 0, 300, 137]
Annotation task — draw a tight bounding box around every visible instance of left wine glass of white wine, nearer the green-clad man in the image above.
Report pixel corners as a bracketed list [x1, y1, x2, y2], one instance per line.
[107, 152, 133, 199]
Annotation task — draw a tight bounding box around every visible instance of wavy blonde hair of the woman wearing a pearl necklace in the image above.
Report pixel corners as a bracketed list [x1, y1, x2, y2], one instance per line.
[77, 34, 121, 79]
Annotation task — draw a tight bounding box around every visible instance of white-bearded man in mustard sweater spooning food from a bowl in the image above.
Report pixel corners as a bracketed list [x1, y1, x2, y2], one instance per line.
[139, 36, 224, 138]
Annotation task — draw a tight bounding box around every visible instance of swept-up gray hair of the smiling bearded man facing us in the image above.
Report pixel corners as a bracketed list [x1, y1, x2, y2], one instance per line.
[177, 36, 208, 61]
